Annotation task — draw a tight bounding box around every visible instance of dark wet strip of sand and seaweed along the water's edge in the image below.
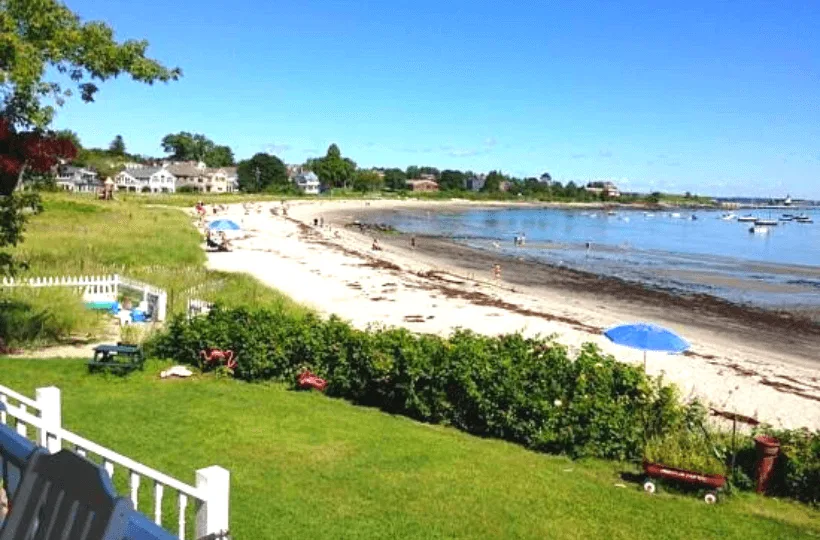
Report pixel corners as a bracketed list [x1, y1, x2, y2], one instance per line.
[325, 201, 820, 356]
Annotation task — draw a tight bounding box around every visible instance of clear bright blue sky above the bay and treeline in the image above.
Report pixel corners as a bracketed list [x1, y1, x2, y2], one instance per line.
[55, 0, 820, 198]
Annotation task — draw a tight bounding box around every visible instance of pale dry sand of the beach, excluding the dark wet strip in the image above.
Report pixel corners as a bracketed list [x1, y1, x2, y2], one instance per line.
[203, 200, 820, 429]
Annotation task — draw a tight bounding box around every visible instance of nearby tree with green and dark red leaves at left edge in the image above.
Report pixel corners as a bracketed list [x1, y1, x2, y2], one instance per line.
[0, 0, 181, 274]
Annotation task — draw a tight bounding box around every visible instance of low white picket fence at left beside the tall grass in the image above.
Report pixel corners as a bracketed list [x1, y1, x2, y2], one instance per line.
[0, 274, 168, 321]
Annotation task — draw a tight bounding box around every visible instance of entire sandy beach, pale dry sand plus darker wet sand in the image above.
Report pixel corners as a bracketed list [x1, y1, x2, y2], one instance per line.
[203, 201, 820, 429]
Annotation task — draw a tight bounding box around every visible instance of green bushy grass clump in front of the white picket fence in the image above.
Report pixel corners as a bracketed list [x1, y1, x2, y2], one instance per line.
[0, 287, 104, 345]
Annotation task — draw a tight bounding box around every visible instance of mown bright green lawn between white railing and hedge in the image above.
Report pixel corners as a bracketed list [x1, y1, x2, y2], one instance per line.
[0, 359, 820, 540]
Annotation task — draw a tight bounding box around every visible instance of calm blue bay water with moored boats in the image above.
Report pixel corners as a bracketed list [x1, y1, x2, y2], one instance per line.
[379, 208, 820, 310]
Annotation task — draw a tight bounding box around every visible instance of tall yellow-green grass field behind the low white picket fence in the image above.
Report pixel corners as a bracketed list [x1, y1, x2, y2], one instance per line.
[0, 194, 303, 346]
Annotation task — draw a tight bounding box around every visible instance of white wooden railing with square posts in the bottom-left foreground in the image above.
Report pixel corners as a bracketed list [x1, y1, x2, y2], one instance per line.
[0, 385, 230, 540]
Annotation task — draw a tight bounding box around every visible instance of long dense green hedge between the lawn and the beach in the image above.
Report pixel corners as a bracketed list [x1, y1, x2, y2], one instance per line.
[148, 307, 820, 503]
